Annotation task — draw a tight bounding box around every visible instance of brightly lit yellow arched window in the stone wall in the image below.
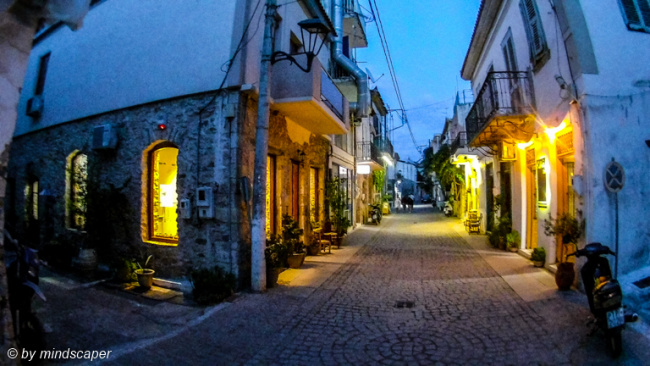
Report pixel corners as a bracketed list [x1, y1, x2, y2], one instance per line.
[147, 142, 178, 244]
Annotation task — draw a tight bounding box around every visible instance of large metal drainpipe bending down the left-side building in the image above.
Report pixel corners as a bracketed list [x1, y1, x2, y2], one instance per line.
[332, 0, 370, 118]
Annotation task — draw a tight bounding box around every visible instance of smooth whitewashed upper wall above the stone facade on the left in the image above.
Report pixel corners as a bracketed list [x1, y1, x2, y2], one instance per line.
[16, 0, 238, 135]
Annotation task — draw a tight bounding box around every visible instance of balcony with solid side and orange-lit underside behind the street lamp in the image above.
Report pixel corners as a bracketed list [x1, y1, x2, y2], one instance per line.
[271, 59, 350, 135]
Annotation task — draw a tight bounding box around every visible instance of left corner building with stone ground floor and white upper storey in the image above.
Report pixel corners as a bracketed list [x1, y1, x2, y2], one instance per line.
[7, 0, 380, 287]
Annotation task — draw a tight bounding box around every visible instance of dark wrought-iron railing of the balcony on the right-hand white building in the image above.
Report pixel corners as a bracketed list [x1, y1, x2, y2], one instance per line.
[466, 71, 534, 143]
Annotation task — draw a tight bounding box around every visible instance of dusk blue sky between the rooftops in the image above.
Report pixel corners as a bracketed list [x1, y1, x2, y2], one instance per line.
[357, 0, 480, 161]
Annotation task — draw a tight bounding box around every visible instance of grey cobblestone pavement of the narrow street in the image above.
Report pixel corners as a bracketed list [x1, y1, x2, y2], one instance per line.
[46, 206, 650, 365]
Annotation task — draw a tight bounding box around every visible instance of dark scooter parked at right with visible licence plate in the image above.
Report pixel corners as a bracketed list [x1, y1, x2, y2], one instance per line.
[567, 243, 638, 357]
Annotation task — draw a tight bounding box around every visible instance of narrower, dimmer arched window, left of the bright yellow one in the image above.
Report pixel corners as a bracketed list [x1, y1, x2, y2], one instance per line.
[66, 151, 88, 231]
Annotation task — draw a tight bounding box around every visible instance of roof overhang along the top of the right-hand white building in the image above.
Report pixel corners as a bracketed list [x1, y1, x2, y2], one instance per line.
[460, 0, 503, 80]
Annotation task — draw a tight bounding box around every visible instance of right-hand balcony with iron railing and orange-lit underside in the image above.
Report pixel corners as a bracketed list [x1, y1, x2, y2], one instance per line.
[466, 71, 535, 147]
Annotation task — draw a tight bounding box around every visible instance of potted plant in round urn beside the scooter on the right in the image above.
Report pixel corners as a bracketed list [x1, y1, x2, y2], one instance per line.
[544, 212, 582, 291]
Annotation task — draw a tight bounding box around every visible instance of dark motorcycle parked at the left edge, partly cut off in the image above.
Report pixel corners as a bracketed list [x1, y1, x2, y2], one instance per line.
[4, 230, 46, 350]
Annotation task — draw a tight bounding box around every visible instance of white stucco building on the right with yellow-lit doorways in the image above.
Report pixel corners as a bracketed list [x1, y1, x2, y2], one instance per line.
[461, 0, 650, 286]
